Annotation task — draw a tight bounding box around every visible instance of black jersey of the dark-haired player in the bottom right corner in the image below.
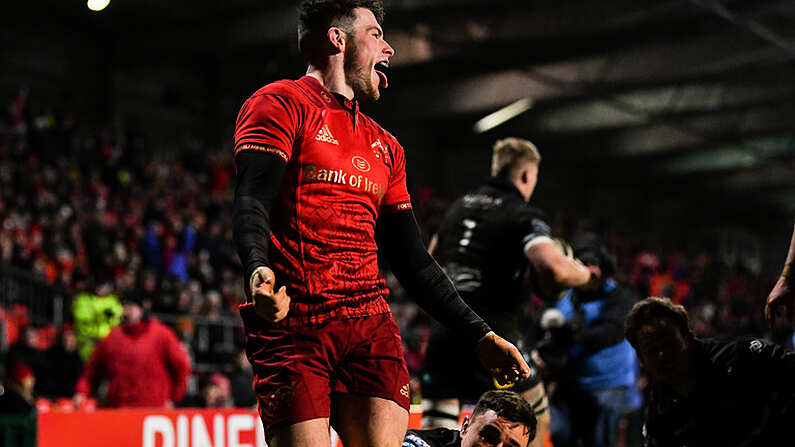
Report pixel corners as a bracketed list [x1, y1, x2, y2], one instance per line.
[643, 337, 795, 447]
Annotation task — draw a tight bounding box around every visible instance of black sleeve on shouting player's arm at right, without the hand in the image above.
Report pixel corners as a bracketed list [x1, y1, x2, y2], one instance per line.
[377, 210, 491, 344]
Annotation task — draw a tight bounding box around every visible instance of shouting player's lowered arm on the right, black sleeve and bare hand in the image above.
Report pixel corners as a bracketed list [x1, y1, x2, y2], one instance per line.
[378, 209, 530, 383]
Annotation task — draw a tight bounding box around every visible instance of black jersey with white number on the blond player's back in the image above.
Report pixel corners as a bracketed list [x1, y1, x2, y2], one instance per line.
[434, 177, 550, 341]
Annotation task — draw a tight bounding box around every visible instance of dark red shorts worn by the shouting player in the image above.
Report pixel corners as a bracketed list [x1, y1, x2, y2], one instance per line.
[240, 304, 410, 439]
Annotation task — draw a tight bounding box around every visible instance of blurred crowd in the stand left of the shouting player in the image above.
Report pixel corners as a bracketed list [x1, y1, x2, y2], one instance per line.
[0, 93, 253, 406]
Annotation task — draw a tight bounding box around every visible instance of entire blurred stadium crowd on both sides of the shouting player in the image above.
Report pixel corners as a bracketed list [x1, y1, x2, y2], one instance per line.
[0, 92, 792, 440]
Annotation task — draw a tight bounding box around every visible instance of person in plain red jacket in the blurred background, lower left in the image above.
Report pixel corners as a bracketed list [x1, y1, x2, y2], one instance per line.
[74, 295, 191, 408]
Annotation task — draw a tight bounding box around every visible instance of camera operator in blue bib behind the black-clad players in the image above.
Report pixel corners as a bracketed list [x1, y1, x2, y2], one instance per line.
[536, 234, 637, 447]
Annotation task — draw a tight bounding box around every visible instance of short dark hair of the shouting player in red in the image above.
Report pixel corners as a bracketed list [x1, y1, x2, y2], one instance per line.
[298, 0, 385, 59]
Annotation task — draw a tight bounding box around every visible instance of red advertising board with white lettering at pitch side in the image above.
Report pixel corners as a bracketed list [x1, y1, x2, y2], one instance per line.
[38, 409, 422, 447]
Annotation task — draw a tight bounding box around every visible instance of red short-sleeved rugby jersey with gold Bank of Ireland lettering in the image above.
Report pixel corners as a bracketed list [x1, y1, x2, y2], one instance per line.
[235, 76, 411, 326]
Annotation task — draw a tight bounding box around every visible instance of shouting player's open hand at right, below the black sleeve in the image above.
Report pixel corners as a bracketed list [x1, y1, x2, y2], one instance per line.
[475, 332, 530, 385]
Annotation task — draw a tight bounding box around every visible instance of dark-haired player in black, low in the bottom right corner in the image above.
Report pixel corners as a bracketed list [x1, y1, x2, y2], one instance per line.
[625, 297, 795, 447]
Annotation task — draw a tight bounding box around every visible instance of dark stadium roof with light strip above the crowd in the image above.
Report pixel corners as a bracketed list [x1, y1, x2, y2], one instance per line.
[9, 0, 795, 224]
